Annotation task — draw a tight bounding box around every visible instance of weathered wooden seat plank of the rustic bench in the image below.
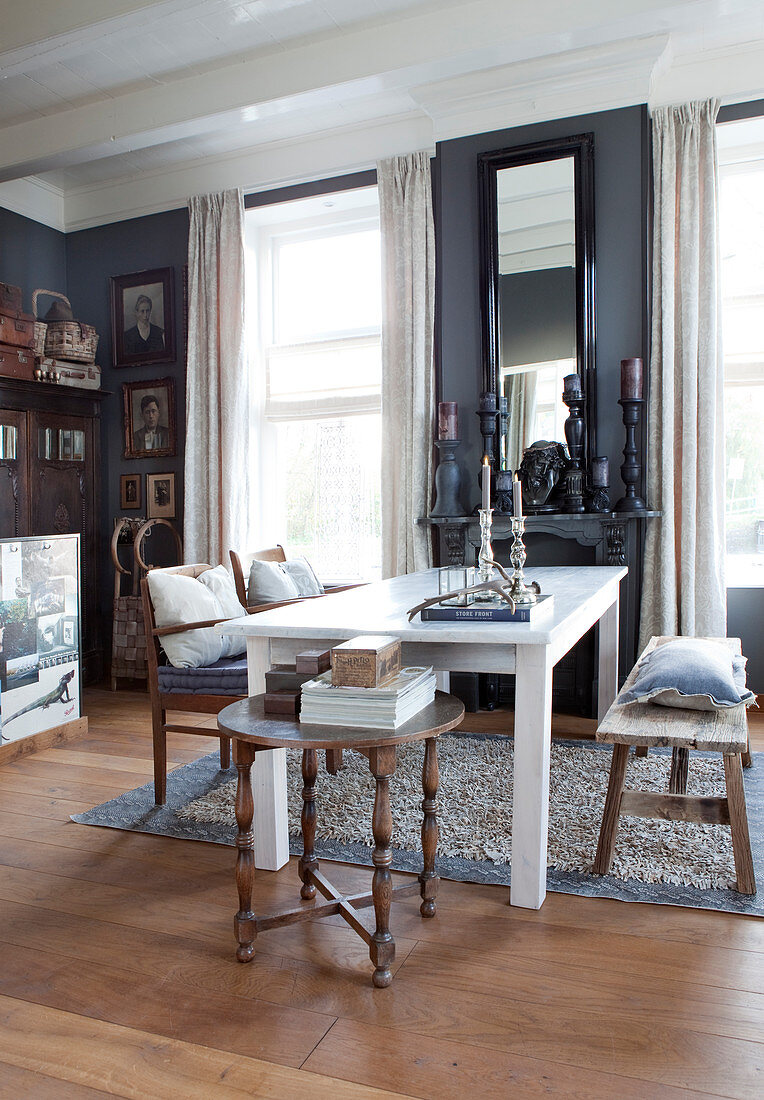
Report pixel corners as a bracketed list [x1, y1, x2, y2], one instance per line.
[597, 636, 748, 752]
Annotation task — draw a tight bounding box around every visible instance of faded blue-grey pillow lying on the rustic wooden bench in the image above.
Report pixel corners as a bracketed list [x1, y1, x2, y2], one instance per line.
[619, 638, 756, 711]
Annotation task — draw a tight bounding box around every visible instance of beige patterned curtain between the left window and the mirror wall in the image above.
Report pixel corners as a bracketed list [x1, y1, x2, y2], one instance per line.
[377, 153, 435, 576]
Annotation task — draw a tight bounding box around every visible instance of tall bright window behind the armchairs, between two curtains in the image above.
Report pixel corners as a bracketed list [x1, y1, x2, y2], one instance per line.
[247, 188, 381, 581]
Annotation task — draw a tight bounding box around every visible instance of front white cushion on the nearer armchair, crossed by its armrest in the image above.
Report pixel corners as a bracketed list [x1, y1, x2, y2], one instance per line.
[146, 570, 224, 669]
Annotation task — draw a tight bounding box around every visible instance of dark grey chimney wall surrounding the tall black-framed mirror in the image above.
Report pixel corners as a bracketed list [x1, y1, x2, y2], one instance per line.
[434, 107, 647, 509]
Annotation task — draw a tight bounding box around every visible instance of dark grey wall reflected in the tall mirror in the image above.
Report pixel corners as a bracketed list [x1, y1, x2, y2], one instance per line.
[499, 267, 576, 366]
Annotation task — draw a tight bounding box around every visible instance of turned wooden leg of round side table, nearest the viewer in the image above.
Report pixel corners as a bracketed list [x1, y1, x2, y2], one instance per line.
[368, 745, 396, 989]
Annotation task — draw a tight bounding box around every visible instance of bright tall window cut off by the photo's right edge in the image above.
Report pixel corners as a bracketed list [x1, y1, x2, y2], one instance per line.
[718, 119, 764, 587]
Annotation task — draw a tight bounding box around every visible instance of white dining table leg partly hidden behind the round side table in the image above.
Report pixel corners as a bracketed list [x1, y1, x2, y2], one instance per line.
[246, 638, 289, 871]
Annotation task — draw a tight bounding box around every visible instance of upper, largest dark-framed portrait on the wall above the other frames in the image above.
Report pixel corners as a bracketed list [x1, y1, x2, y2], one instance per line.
[111, 267, 175, 366]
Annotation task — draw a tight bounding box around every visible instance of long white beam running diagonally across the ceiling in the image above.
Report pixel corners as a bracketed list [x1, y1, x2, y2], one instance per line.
[0, 0, 703, 180]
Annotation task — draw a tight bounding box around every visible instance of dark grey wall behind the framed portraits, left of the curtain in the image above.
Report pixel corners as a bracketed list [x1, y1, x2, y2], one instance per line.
[66, 210, 188, 611]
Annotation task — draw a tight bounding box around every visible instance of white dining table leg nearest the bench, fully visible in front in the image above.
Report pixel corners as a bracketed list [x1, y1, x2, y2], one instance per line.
[509, 646, 552, 909]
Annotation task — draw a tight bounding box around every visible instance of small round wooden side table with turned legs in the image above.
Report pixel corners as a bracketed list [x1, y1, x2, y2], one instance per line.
[218, 691, 464, 988]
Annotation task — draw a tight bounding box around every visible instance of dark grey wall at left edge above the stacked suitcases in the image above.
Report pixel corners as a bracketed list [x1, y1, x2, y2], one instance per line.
[0, 207, 66, 314]
